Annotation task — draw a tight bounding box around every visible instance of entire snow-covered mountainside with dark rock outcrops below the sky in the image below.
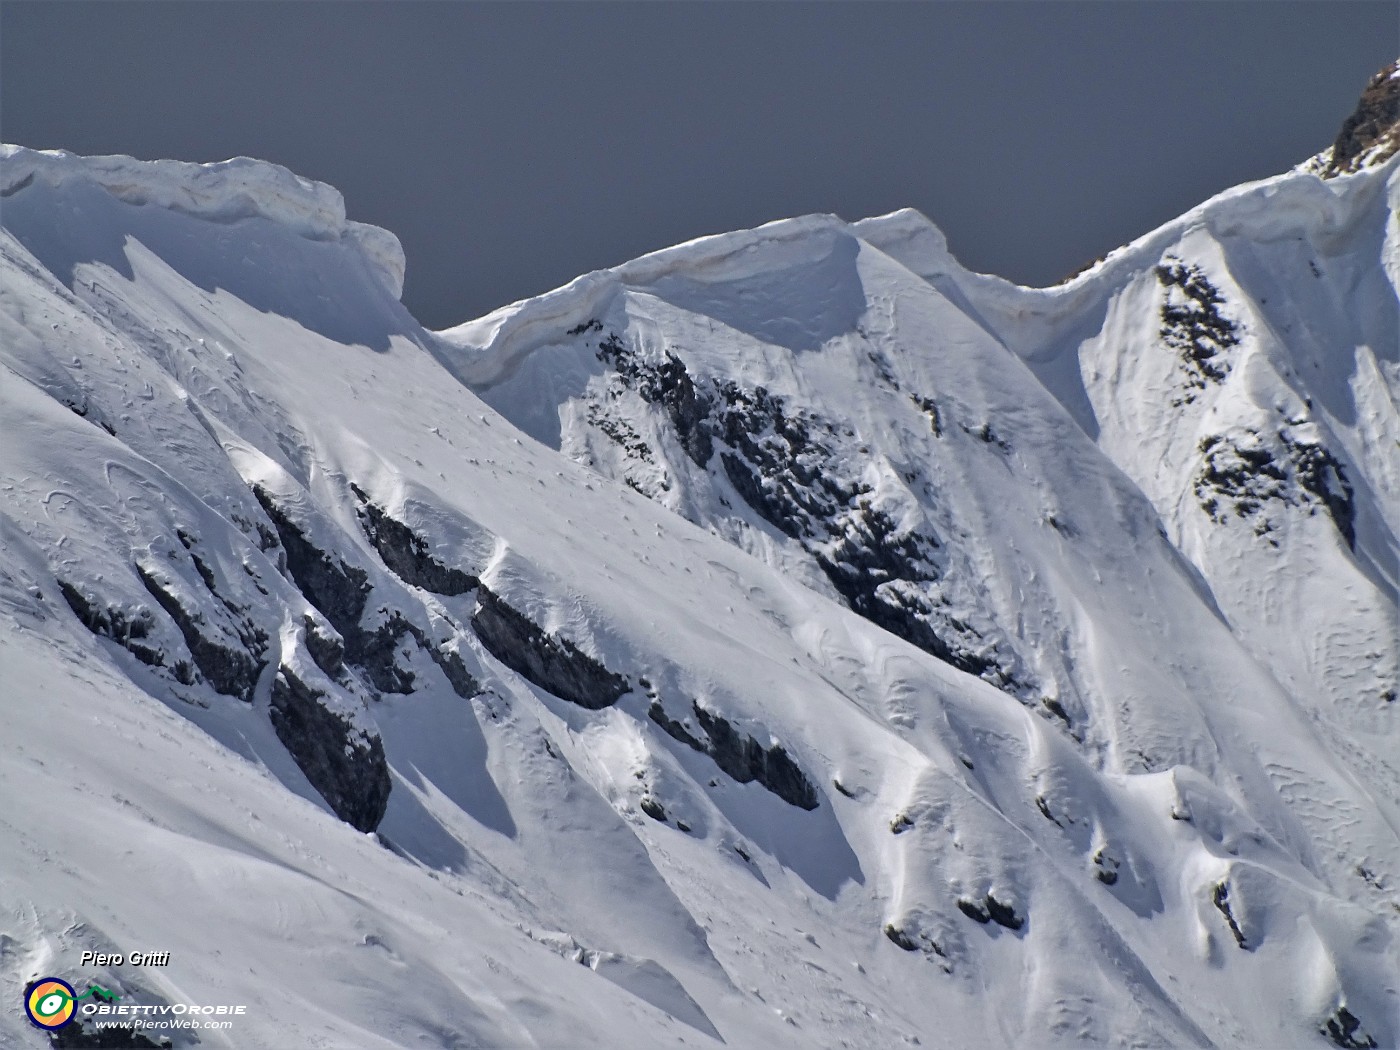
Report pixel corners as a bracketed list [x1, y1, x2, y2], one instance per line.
[0, 100, 1400, 1047]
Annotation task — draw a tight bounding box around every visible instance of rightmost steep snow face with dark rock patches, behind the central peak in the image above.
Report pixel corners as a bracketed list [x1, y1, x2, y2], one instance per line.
[862, 161, 1400, 783]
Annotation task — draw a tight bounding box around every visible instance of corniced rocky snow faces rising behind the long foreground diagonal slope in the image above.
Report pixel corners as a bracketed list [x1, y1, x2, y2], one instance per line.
[438, 156, 1400, 1047]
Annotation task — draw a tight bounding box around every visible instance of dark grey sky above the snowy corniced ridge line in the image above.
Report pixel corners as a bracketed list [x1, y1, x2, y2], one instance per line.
[0, 0, 1400, 328]
